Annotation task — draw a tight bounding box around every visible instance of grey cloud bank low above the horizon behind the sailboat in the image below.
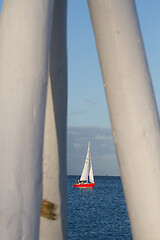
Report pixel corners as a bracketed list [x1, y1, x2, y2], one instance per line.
[67, 127, 119, 176]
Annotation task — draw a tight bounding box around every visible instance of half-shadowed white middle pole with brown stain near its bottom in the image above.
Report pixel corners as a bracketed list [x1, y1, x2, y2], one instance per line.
[40, 0, 68, 240]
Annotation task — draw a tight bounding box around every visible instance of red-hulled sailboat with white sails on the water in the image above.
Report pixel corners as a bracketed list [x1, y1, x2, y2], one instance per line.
[73, 141, 95, 188]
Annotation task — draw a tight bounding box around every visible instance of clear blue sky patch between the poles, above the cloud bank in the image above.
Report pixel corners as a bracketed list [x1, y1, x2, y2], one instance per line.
[67, 0, 109, 127]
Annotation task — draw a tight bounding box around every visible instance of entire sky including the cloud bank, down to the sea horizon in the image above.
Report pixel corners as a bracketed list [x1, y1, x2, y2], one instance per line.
[0, 0, 160, 176]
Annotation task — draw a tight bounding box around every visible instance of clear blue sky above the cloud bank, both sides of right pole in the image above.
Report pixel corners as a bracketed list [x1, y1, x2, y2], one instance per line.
[68, 0, 160, 127]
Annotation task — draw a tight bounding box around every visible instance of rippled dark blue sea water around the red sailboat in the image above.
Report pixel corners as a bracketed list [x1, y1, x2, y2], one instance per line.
[68, 176, 132, 240]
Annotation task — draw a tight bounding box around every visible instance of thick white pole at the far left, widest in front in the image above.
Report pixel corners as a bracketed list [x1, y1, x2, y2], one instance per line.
[0, 0, 53, 240]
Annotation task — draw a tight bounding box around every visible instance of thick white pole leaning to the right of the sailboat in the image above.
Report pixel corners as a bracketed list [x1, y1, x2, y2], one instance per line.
[88, 0, 160, 240]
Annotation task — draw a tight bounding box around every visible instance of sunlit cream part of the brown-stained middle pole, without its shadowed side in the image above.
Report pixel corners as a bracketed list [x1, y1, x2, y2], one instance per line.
[40, 79, 62, 240]
